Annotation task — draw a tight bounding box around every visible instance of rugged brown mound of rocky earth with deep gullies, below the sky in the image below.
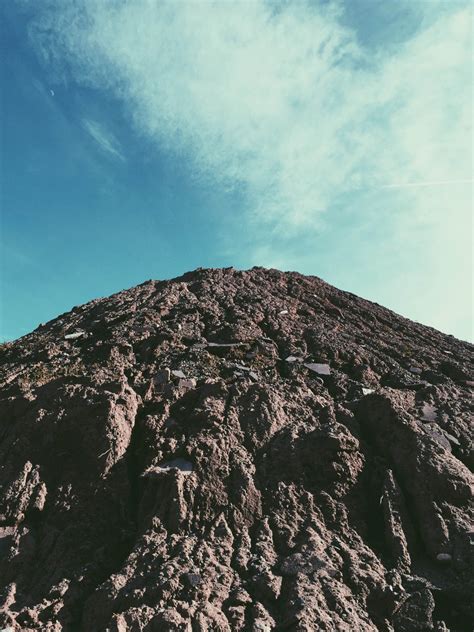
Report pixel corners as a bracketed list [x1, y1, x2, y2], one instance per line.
[0, 268, 474, 632]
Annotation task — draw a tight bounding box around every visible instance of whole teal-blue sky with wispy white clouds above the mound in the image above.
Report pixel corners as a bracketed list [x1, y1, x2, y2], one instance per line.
[0, 0, 473, 340]
